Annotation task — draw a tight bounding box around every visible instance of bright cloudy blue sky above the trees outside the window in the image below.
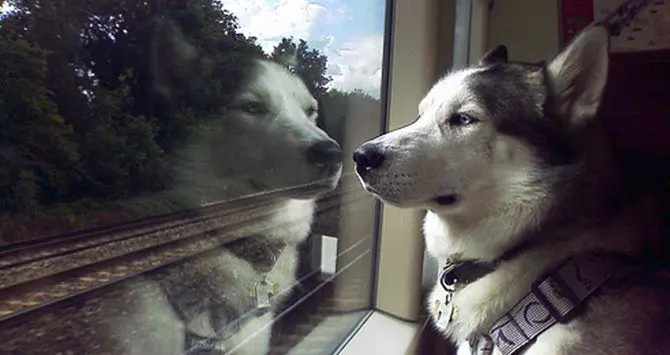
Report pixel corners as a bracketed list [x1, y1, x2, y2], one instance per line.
[221, 0, 386, 98]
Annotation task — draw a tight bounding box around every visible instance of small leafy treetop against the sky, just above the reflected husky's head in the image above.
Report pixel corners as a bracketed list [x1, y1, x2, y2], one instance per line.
[270, 37, 332, 99]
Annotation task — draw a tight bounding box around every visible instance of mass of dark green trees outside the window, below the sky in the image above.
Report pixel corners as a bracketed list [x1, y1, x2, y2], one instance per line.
[0, 0, 380, 239]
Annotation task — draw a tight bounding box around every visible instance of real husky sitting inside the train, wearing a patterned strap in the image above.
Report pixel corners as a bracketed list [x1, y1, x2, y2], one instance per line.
[353, 24, 670, 355]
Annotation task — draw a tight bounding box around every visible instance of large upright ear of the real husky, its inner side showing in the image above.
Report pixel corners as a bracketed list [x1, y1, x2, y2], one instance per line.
[547, 25, 609, 124]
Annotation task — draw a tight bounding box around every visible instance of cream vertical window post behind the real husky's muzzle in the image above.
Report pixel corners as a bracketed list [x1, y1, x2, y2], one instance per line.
[374, 0, 440, 322]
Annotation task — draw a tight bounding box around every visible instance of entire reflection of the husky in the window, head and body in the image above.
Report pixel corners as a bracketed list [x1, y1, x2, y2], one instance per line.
[14, 60, 342, 355]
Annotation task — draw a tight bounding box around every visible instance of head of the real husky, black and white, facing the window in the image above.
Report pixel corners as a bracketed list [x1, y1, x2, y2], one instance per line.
[354, 26, 609, 215]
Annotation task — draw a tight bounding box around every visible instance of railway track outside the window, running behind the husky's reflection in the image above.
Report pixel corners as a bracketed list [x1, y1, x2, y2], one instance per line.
[0, 188, 367, 322]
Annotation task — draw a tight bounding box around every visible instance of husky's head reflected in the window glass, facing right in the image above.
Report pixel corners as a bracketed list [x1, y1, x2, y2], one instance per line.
[189, 60, 342, 199]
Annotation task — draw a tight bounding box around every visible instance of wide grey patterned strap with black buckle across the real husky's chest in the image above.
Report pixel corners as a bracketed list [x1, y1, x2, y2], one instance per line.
[470, 253, 618, 355]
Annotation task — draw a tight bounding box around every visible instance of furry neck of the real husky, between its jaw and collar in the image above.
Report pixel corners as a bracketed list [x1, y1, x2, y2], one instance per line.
[424, 161, 636, 262]
